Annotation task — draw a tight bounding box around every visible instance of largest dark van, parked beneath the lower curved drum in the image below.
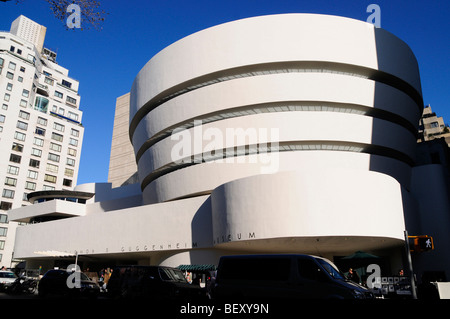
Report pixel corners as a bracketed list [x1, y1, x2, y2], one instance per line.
[213, 255, 373, 299]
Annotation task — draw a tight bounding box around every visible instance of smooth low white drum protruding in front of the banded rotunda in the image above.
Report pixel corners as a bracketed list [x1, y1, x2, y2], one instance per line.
[211, 170, 405, 255]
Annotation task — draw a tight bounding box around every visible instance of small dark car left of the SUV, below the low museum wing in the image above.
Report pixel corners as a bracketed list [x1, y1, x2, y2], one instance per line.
[38, 269, 100, 298]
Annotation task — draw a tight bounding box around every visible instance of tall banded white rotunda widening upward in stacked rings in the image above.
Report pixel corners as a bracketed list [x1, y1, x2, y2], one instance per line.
[130, 14, 422, 208]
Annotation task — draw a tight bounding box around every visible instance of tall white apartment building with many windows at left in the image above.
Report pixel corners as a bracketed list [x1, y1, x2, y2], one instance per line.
[0, 16, 84, 267]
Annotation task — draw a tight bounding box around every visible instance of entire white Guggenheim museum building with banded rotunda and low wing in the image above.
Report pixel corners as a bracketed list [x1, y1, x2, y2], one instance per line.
[12, 14, 450, 280]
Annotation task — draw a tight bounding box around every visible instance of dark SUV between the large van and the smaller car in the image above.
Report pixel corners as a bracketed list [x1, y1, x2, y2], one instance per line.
[106, 266, 206, 300]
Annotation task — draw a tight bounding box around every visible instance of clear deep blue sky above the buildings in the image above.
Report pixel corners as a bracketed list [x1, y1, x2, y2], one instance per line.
[0, 0, 450, 184]
